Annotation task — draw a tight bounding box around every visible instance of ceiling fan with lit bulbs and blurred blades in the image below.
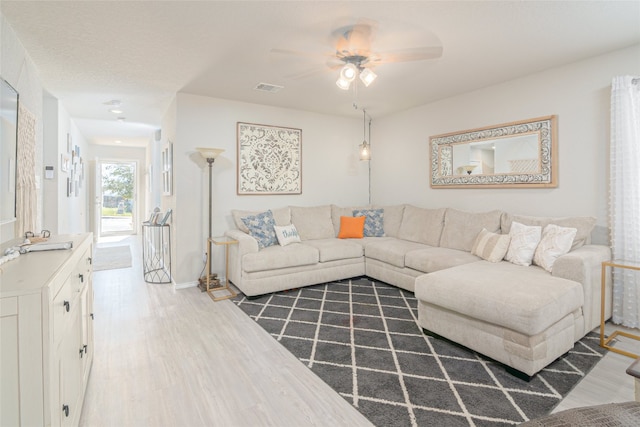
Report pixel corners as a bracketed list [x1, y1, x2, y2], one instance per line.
[271, 20, 442, 90]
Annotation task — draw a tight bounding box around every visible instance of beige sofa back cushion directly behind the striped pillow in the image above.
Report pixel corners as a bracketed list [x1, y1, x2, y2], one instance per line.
[438, 209, 502, 252]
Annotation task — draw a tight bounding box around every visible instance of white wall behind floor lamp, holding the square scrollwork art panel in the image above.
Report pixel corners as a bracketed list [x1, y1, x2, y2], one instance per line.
[170, 94, 369, 285]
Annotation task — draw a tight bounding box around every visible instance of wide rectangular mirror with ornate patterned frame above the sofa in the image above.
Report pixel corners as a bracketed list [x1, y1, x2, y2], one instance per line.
[429, 115, 558, 188]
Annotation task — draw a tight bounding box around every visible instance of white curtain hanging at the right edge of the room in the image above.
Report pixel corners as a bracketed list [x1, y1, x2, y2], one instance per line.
[610, 76, 640, 328]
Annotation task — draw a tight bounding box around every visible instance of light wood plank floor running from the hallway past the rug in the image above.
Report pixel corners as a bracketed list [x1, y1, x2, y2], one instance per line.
[80, 237, 634, 427]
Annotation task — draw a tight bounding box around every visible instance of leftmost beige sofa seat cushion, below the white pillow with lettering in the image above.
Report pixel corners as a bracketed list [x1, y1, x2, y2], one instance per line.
[242, 243, 320, 273]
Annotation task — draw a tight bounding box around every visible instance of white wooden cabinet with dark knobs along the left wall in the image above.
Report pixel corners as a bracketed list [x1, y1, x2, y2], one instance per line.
[0, 233, 93, 426]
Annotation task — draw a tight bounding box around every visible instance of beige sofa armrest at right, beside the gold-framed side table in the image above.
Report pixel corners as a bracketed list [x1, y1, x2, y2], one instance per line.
[552, 245, 611, 339]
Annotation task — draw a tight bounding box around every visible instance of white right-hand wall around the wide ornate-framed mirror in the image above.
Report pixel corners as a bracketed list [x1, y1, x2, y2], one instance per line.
[371, 45, 640, 237]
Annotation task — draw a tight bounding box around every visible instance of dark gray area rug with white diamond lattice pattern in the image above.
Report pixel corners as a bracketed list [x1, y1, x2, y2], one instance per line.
[233, 277, 606, 426]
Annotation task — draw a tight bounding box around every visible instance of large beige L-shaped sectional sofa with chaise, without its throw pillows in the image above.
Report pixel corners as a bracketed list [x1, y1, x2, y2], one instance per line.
[226, 205, 611, 376]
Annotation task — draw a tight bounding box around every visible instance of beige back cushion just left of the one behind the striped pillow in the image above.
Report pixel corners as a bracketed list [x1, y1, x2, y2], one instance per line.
[398, 205, 444, 246]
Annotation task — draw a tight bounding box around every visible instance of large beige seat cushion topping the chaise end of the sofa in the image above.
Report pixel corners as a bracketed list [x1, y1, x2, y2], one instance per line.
[415, 261, 584, 336]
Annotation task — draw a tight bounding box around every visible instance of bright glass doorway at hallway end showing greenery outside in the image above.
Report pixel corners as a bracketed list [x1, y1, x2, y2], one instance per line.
[98, 160, 138, 236]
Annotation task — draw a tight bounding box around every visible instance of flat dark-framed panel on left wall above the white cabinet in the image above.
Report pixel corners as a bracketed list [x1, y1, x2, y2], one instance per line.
[0, 78, 19, 224]
